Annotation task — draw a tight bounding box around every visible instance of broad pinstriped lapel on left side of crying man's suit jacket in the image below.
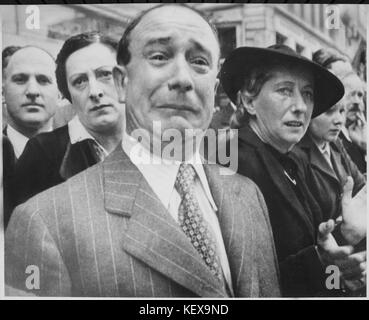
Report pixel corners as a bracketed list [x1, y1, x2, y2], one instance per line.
[103, 148, 226, 297]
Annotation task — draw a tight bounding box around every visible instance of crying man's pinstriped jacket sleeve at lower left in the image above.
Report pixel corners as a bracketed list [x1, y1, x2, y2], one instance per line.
[5, 201, 71, 296]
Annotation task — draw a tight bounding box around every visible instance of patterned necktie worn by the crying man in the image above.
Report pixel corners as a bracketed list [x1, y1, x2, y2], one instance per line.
[175, 163, 223, 281]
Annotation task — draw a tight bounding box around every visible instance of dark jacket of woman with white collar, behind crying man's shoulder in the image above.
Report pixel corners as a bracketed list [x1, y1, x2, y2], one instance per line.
[14, 125, 98, 205]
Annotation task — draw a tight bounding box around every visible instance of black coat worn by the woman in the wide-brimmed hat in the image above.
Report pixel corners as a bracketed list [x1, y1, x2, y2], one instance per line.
[224, 125, 330, 297]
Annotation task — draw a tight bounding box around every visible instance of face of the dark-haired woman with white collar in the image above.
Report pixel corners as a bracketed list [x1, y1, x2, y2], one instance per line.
[65, 43, 123, 132]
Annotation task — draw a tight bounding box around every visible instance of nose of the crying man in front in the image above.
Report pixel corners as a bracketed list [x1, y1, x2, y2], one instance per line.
[168, 57, 194, 93]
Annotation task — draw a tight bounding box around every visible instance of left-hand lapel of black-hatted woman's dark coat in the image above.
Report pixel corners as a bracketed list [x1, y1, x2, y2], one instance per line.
[238, 125, 315, 238]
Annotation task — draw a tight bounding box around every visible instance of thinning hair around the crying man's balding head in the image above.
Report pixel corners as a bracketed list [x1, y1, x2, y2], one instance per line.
[117, 3, 219, 66]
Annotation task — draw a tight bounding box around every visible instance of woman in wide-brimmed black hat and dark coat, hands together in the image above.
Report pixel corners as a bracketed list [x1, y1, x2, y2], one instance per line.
[220, 45, 362, 296]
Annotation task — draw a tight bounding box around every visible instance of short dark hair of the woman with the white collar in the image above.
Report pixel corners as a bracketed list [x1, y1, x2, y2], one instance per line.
[55, 31, 118, 102]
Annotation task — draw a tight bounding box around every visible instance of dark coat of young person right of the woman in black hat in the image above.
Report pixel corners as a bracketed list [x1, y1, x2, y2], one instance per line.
[293, 134, 366, 220]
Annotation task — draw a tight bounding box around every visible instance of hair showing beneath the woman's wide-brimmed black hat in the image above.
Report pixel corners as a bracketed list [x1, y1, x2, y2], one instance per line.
[230, 64, 273, 129]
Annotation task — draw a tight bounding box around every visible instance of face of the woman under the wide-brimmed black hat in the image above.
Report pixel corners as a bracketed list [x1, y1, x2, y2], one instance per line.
[247, 66, 314, 152]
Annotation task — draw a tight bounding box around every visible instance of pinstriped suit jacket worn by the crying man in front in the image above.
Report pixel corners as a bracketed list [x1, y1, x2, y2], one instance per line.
[5, 146, 280, 297]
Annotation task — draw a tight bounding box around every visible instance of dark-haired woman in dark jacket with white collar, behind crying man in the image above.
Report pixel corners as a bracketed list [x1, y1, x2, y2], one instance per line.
[10, 32, 124, 218]
